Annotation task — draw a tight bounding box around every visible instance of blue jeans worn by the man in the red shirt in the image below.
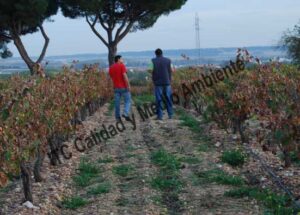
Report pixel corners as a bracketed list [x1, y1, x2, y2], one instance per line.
[115, 89, 131, 119]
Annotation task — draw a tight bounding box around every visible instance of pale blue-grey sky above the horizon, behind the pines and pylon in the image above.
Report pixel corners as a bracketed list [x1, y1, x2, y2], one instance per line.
[4, 0, 300, 56]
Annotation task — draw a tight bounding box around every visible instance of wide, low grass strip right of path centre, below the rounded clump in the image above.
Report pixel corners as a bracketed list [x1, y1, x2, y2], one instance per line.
[195, 169, 245, 186]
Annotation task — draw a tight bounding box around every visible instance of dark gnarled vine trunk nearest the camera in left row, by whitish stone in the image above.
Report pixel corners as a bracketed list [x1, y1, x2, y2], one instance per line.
[20, 162, 33, 202]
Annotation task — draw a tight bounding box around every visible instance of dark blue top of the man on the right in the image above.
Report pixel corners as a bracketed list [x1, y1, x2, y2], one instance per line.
[152, 56, 172, 86]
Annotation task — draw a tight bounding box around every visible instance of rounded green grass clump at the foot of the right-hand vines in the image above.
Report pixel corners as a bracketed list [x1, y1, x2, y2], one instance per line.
[221, 150, 246, 167]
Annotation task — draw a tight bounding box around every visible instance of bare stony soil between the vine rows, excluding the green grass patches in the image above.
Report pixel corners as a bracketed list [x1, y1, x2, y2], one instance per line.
[0, 105, 270, 215]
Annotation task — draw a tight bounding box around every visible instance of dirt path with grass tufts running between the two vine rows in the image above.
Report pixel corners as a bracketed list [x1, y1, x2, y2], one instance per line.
[61, 103, 261, 215]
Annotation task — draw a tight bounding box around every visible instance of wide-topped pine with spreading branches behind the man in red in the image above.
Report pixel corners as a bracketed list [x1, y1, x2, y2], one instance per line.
[61, 0, 187, 64]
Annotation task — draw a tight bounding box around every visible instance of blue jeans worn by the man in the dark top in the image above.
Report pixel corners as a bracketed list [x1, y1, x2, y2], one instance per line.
[155, 85, 173, 119]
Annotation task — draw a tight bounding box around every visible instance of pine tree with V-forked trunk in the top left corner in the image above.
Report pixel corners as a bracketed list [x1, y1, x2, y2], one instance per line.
[0, 0, 58, 72]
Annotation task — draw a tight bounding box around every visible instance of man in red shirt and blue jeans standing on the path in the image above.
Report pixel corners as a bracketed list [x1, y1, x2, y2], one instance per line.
[109, 55, 131, 121]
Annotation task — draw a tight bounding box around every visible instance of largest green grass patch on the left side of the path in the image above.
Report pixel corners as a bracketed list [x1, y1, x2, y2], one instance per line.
[73, 159, 101, 187]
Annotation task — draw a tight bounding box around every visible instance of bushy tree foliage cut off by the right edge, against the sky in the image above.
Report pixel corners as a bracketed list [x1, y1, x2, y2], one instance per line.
[282, 23, 300, 65]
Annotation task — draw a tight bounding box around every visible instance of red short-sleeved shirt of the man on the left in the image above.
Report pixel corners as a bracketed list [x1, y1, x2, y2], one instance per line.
[109, 63, 127, 89]
